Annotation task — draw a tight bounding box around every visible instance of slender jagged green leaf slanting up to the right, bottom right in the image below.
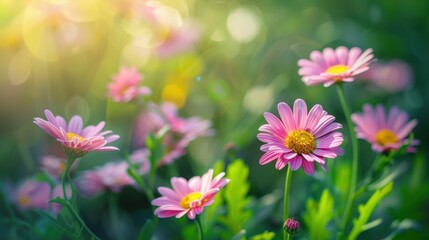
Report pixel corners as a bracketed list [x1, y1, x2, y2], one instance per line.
[348, 182, 393, 240]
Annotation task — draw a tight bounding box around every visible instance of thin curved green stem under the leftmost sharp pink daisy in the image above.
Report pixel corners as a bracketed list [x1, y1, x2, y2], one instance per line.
[61, 156, 100, 240]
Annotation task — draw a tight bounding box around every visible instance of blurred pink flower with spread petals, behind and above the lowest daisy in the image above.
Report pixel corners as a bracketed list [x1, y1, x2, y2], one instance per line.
[134, 103, 213, 165]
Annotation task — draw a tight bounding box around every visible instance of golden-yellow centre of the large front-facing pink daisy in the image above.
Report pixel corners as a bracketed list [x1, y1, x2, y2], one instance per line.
[285, 130, 316, 154]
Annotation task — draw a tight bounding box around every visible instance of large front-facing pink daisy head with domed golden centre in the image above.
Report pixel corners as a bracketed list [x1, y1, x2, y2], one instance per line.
[257, 99, 343, 175]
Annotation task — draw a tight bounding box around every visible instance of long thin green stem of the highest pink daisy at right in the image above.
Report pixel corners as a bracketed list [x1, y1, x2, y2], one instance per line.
[337, 83, 358, 234]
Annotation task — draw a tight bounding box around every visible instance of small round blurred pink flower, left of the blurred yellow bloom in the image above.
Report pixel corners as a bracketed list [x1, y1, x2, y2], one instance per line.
[108, 67, 151, 102]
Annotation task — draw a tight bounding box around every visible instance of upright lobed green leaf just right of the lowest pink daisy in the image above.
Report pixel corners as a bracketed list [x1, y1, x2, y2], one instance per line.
[219, 159, 252, 236]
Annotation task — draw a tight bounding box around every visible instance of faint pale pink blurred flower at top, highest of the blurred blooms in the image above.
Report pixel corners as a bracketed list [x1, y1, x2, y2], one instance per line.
[156, 22, 201, 57]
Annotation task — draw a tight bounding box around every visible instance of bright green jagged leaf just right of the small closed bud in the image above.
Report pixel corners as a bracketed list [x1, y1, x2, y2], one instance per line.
[303, 189, 334, 239]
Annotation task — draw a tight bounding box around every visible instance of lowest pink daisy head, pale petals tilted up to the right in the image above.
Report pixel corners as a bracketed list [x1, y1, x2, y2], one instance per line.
[152, 169, 229, 219]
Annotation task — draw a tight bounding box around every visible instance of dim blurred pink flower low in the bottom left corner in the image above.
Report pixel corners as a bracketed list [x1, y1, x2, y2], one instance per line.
[14, 179, 71, 213]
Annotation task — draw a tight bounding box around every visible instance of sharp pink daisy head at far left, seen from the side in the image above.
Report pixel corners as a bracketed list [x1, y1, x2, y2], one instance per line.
[34, 110, 119, 158]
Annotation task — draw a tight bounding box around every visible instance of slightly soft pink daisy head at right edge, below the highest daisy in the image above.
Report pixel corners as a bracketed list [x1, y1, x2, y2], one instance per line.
[352, 104, 418, 152]
